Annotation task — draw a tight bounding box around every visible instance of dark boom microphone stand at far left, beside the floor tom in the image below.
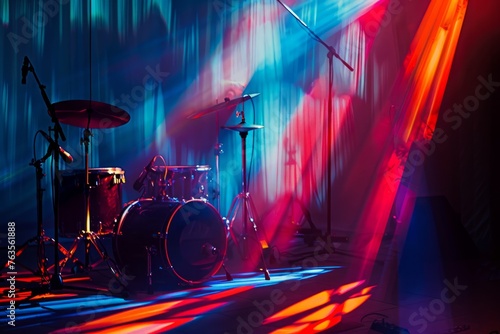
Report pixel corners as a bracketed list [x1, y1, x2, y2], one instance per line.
[25, 57, 66, 289]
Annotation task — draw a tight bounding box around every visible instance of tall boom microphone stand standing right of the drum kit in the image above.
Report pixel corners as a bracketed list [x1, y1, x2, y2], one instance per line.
[277, 0, 354, 242]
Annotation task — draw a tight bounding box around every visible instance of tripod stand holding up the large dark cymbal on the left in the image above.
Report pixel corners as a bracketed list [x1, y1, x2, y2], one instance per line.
[63, 126, 120, 281]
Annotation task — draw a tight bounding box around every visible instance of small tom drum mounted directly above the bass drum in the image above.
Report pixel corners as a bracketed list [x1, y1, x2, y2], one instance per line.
[142, 165, 211, 201]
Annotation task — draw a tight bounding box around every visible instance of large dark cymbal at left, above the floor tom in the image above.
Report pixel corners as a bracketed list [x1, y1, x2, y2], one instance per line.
[52, 100, 130, 129]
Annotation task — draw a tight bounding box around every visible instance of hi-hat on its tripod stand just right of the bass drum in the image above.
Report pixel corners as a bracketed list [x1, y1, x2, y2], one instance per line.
[224, 111, 271, 280]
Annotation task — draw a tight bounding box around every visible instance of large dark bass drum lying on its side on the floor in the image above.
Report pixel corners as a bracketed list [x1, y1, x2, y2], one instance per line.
[113, 199, 227, 284]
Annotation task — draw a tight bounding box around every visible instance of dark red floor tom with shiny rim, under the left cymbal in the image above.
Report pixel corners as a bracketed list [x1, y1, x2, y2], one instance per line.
[59, 167, 125, 237]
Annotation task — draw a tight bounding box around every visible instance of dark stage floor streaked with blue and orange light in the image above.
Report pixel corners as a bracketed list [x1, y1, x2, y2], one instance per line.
[1, 232, 500, 333]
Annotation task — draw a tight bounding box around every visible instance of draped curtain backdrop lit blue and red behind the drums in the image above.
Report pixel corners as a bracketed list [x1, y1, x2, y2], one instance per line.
[0, 0, 498, 280]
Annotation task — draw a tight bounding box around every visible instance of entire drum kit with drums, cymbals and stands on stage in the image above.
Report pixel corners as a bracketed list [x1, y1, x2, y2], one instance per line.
[13, 88, 270, 291]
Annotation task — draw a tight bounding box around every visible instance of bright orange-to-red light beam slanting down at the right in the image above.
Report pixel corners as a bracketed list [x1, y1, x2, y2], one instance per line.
[352, 0, 466, 277]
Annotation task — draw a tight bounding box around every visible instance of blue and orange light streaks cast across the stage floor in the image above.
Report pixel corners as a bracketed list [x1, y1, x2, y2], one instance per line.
[5, 266, 354, 333]
